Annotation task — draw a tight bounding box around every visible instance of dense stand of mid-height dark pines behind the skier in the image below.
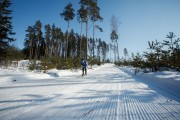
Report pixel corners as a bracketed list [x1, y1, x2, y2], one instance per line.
[23, 20, 109, 69]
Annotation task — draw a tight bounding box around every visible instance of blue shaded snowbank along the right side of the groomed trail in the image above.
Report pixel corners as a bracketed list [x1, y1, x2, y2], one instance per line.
[121, 67, 180, 102]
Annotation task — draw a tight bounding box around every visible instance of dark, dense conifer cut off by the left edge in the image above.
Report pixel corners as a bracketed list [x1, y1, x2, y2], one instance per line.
[0, 0, 15, 62]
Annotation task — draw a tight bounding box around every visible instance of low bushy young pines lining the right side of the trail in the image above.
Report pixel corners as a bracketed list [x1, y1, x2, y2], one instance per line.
[116, 32, 180, 71]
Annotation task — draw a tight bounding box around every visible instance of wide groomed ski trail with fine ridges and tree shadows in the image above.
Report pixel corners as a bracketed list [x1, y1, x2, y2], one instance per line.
[0, 64, 180, 120]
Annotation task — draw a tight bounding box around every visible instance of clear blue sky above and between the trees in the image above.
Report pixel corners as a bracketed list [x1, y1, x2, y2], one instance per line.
[11, 0, 180, 56]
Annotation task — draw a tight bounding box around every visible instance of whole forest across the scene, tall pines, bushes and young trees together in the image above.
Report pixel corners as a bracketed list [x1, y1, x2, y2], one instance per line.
[0, 0, 180, 71]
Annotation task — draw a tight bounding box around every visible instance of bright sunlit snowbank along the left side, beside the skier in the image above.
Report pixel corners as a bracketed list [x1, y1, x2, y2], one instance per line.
[0, 60, 102, 85]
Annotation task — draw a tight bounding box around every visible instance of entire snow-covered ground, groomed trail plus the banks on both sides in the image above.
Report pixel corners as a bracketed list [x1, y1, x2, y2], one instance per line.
[0, 64, 180, 120]
